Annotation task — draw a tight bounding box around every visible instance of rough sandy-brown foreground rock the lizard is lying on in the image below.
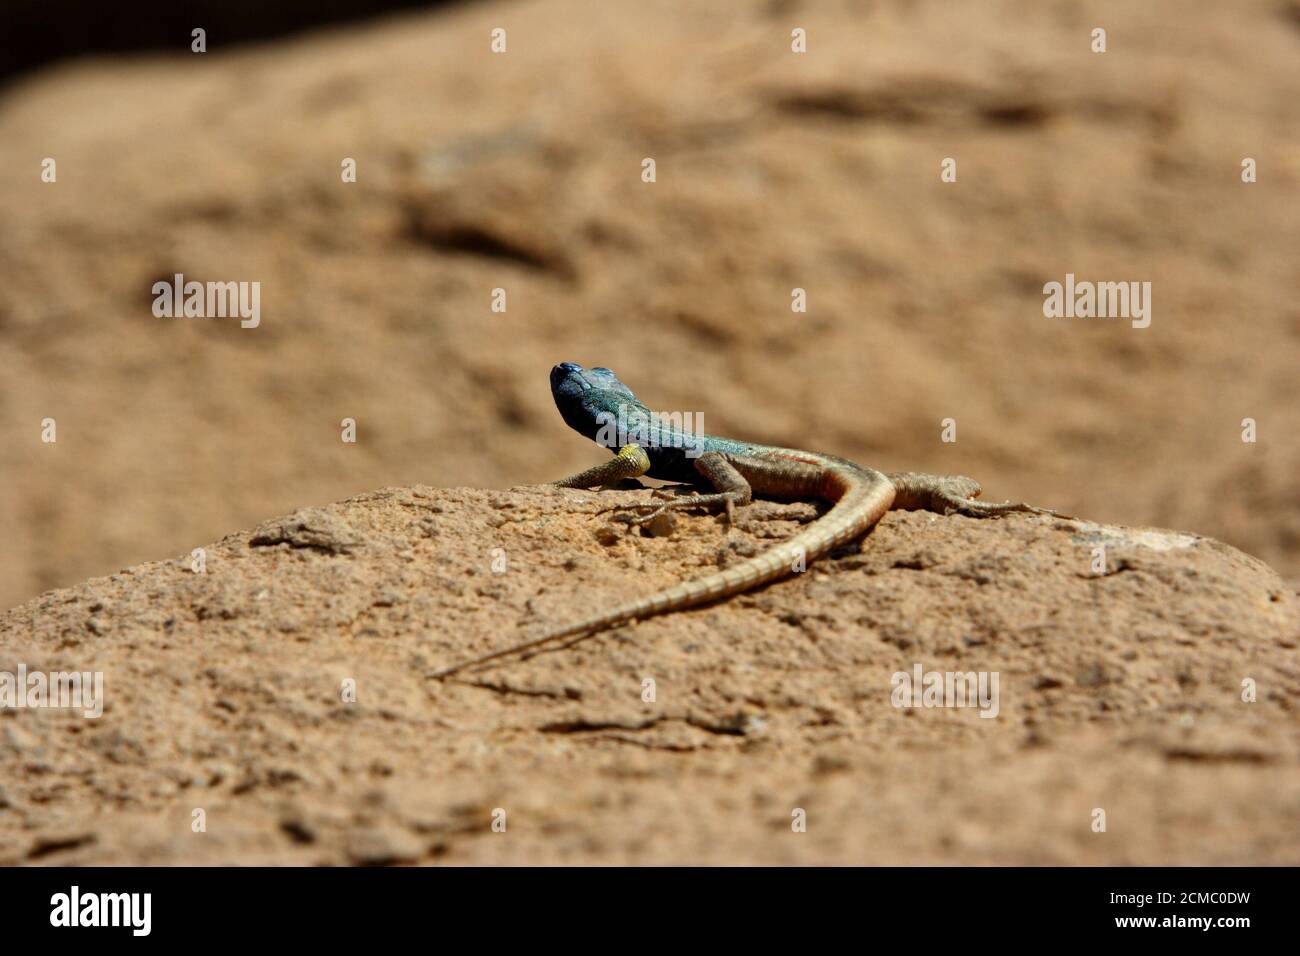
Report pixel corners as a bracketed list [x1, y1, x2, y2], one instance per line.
[0, 486, 1300, 865]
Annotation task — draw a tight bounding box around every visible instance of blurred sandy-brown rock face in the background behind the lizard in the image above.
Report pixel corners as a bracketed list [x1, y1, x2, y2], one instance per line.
[0, 0, 1300, 613]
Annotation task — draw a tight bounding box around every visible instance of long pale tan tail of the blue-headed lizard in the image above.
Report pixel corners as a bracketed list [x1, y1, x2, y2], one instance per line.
[430, 468, 894, 678]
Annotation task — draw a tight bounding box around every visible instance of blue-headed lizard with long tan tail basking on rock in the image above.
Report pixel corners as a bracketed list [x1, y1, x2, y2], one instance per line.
[430, 362, 1070, 679]
